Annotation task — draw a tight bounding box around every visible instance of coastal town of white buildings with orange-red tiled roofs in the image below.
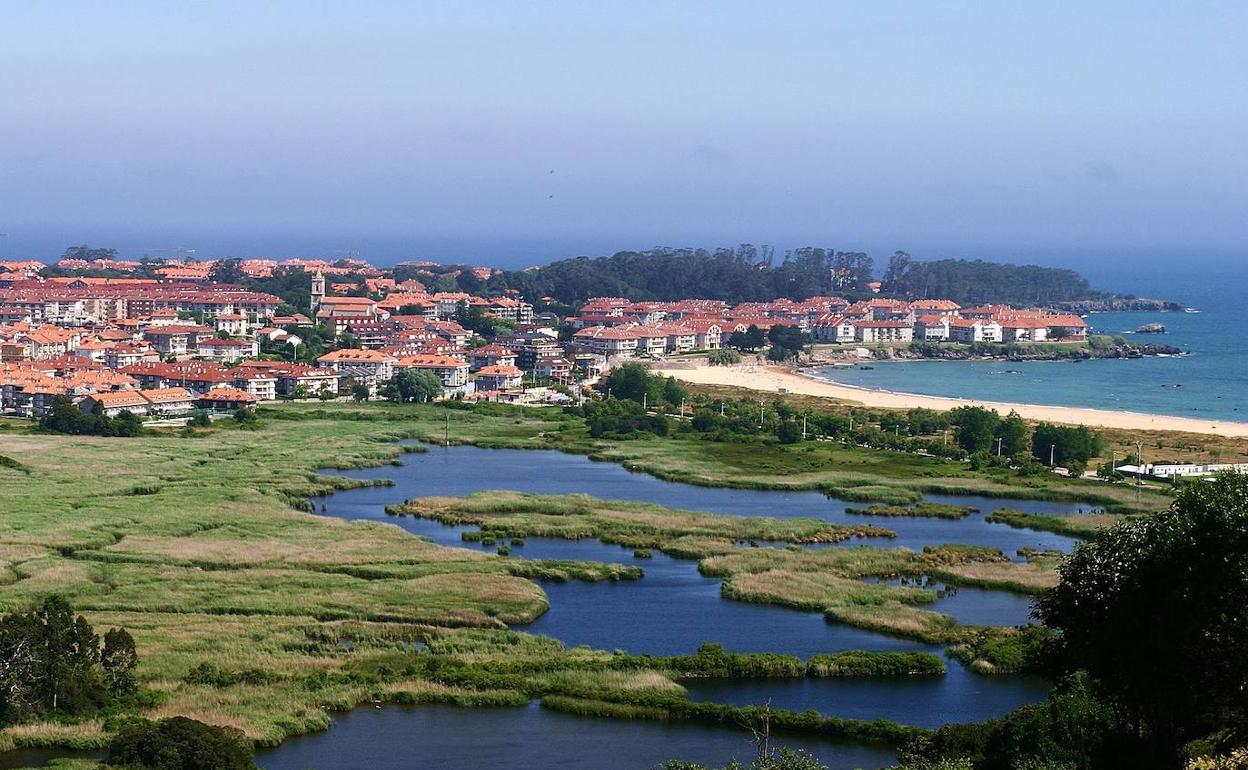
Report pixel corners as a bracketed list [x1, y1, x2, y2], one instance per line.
[0, 252, 1087, 419]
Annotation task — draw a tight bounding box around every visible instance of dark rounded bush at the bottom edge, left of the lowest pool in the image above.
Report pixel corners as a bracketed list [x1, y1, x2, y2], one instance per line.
[105, 716, 256, 770]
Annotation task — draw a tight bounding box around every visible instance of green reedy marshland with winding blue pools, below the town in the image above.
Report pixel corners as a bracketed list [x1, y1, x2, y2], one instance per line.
[0, 404, 1178, 768]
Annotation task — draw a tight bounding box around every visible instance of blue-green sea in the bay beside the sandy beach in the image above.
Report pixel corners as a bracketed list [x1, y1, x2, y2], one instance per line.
[811, 265, 1248, 424]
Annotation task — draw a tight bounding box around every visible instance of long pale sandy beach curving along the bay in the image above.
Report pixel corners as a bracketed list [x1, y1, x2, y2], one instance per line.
[651, 362, 1248, 437]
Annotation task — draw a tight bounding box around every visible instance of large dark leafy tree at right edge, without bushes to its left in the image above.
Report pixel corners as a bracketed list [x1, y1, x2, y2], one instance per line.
[1037, 475, 1248, 768]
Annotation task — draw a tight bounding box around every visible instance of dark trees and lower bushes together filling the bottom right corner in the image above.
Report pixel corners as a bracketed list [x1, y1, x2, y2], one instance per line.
[901, 474, 1248, 770]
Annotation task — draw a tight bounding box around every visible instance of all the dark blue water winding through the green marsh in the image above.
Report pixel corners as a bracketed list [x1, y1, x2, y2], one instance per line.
[240, 447, 1092, 770]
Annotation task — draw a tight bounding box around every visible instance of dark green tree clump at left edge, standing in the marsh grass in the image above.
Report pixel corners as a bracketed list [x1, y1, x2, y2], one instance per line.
[0, 597, 139, 725]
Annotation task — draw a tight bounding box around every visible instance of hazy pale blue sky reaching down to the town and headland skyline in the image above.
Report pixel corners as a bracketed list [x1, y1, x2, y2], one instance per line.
[0, 0, 1248, 270]
